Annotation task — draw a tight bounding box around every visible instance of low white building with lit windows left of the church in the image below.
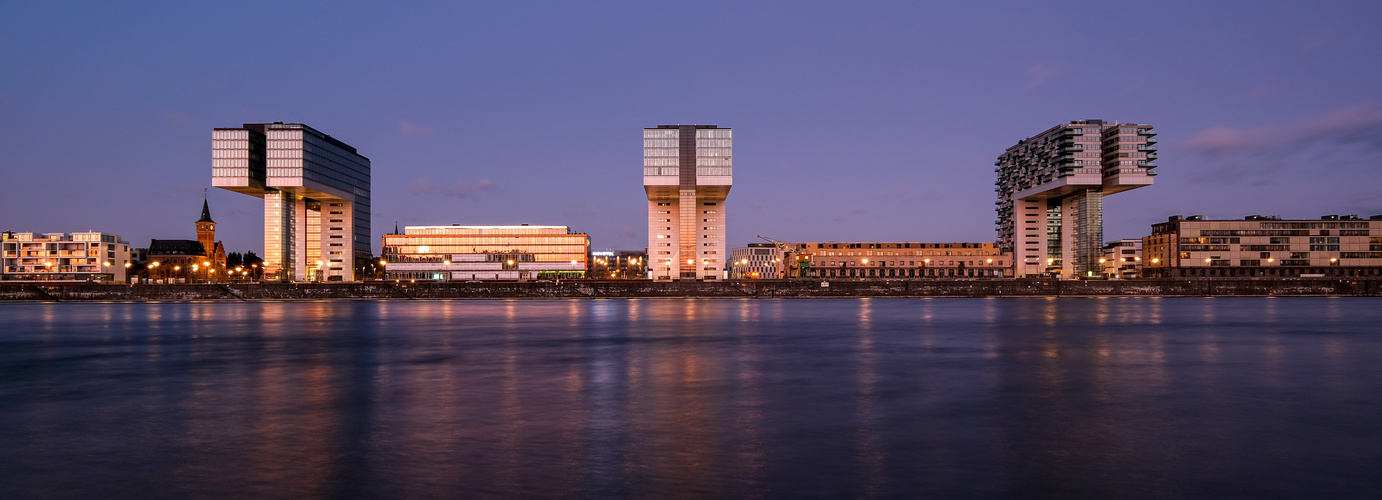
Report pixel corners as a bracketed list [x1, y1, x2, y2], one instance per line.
[0, 231, 130, 283]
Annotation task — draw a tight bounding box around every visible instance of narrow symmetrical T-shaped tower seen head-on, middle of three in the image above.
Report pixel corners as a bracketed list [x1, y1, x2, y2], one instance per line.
[643, 126, 734, 279]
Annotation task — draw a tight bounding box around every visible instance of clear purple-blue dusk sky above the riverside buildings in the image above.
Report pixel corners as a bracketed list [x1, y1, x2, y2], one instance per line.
[0, 1, 1382, 253]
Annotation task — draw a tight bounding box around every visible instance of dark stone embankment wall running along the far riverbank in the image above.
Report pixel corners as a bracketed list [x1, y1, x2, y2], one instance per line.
[8, 279, 1382, 302]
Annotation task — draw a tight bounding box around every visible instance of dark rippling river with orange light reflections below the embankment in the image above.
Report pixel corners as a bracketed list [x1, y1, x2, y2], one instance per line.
[0, 298, 1382, 497]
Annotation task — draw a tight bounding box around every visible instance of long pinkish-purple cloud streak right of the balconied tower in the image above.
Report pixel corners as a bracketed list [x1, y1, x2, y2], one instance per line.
[1183, 102, 1382, 156]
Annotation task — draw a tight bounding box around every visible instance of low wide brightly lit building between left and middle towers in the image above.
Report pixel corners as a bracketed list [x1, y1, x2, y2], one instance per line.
[383, 224, 590, 280]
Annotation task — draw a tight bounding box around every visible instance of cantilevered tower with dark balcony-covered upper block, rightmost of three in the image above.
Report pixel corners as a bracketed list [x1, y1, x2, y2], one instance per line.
[995, 120, 1157, 279]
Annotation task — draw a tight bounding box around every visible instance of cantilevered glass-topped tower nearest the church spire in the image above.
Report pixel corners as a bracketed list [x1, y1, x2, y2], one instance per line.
[211, 122, 372, 280]
